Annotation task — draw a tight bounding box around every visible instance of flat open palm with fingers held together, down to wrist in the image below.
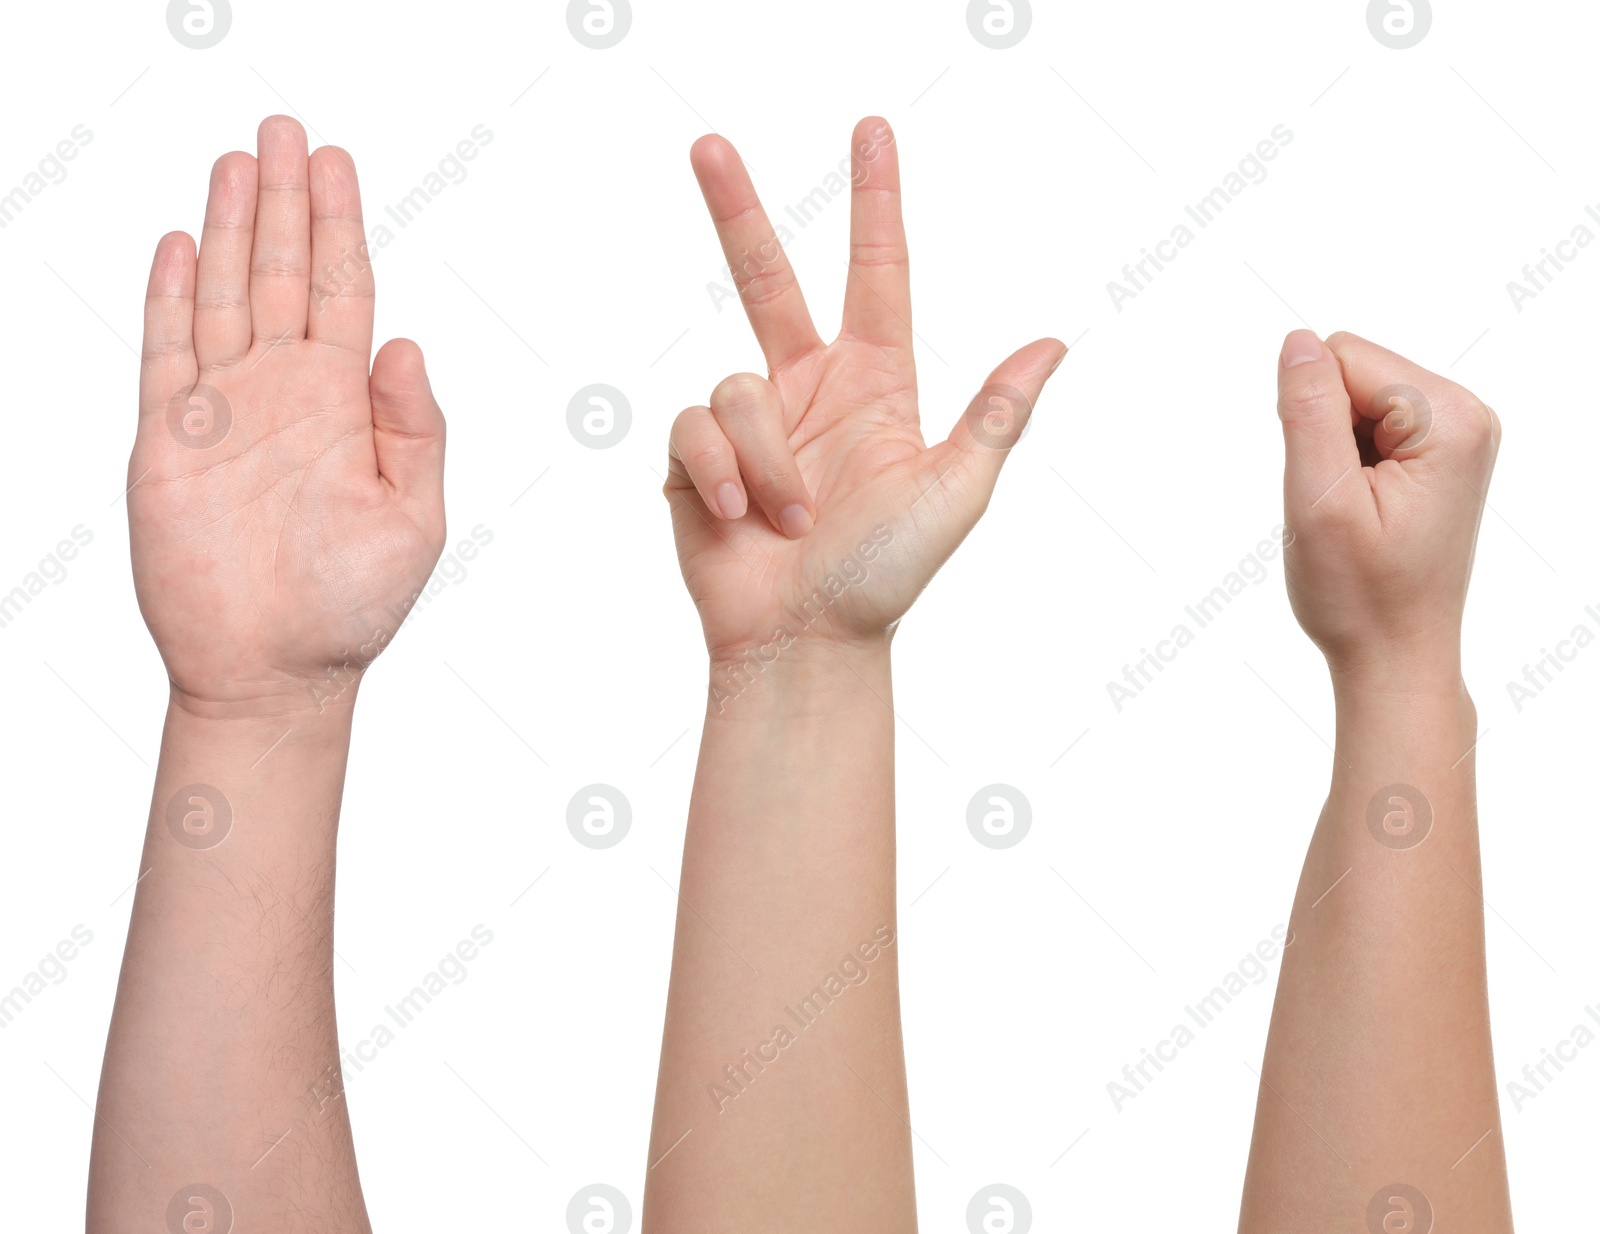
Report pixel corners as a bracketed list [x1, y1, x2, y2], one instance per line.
[128, 115, 445, 711]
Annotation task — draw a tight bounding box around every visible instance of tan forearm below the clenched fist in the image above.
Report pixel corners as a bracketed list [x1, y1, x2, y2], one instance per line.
[1240, 672, 1510, 1234]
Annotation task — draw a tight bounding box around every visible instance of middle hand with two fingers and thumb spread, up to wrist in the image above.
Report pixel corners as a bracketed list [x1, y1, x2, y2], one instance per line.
[666, 118, 1066, 681]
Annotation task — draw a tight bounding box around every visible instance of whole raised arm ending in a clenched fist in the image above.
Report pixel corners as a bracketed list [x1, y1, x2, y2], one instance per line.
[1238, 330, 1512, 1234]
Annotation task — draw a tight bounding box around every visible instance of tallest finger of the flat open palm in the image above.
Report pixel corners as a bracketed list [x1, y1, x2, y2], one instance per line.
[250, 115, 310, 344]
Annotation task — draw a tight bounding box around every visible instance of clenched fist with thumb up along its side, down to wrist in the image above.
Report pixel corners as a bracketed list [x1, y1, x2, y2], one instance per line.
[1278, 330, 1501, 683]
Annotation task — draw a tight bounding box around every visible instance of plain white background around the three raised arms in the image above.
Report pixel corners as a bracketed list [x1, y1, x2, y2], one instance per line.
[0, 0, 1600, 1231]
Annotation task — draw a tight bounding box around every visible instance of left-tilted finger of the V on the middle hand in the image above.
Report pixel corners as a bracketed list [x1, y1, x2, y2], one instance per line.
[690, 134, 822, 373]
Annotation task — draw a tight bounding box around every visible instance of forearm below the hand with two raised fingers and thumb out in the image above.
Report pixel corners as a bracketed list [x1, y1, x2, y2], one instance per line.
[645, 647, 915, 1234]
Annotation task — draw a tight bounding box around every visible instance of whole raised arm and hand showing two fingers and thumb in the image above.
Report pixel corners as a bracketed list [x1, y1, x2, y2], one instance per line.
[643, 118, 1066, 1234]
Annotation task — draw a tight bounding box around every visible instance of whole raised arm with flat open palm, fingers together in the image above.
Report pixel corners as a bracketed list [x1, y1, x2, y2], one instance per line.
[88, 117, 445, 1234]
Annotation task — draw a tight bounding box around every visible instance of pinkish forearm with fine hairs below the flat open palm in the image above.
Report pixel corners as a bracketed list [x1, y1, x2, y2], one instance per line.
[88, 688, 368, 1234]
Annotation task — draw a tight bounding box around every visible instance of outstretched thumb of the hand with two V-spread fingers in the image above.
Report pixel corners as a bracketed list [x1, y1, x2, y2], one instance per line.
[928, 338, 1067, 528]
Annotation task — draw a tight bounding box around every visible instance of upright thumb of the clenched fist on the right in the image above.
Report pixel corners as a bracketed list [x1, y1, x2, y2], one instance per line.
[1278, 330, 1362, 522]
